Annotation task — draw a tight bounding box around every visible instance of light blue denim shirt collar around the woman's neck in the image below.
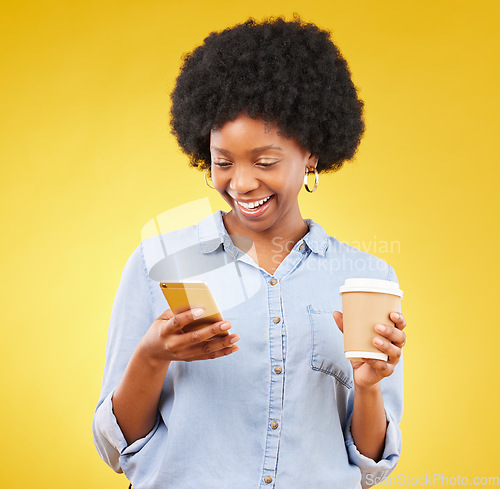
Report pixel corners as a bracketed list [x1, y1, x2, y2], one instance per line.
[198, 210, 328, 258]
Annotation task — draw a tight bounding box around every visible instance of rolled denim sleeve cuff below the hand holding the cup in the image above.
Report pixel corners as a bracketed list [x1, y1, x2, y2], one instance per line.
[346, 411, 402, 488]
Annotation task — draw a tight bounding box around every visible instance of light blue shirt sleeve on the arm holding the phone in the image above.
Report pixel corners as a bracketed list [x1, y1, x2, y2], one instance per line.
[93, 244, 159, 472]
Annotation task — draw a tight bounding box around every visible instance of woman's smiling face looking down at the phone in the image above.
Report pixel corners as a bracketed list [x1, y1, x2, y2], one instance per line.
[210, 111, 317, 240]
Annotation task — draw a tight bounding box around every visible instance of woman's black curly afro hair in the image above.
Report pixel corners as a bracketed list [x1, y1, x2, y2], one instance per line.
[170, 16, 364, 172]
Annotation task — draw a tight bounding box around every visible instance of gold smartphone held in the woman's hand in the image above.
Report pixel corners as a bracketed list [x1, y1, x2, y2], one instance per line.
[160, 281, 228, 336]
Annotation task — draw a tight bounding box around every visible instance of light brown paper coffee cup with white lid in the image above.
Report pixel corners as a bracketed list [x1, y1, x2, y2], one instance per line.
[339, 278, 403, 361]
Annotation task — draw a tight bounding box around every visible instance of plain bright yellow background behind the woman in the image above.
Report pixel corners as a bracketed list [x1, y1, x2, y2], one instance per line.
[0, 0, 500, 489]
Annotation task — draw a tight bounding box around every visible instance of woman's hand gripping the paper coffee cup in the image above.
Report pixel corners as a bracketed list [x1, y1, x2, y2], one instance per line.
[333, 311, 406, 388]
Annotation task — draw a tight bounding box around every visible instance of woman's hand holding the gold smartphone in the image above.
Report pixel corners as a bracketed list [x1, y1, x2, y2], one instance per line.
[139, 309, 240, 364]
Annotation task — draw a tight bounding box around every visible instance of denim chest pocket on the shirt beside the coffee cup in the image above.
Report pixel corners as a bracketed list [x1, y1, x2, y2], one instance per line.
[307, 306, 353, 389]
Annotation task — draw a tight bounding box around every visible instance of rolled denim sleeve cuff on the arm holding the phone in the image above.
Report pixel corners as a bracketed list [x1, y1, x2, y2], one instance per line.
[94, 390, 160, 472]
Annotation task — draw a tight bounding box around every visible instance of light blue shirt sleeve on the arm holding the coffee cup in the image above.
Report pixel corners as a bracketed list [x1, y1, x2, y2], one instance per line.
[345, 265, 403, 488]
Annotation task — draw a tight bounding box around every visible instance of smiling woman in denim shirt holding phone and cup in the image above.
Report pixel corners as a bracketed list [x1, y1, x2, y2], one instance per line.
[94, 18, 406, 489]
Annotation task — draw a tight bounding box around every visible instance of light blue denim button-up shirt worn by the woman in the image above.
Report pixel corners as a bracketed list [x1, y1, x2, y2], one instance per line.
[93, 211, 403, 489]
